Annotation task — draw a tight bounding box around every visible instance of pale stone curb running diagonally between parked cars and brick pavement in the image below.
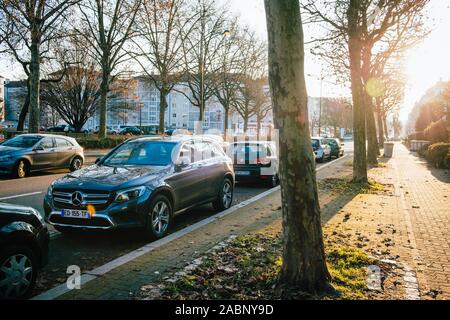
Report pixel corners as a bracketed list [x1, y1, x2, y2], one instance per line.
[31, 155, 349, 300]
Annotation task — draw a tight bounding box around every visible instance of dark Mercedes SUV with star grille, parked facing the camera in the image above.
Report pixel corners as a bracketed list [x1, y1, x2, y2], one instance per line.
[44, 136, 234, 238]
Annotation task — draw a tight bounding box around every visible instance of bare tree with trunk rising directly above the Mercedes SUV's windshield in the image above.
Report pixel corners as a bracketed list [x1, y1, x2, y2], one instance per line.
[132, 0, 192, 133]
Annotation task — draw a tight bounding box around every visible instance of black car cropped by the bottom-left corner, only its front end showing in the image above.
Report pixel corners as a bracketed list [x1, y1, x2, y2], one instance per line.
[0, 203, 49, 299]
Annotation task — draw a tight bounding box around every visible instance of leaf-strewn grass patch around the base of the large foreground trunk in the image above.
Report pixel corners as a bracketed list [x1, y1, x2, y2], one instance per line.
[142, 234, 374, 300]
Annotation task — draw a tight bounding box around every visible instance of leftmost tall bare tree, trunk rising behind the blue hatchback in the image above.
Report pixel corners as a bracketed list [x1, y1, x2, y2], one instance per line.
[0, 0, 81, 132]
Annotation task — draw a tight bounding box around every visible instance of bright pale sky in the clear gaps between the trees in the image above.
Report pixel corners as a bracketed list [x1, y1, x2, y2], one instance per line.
[0, 0, 450, 124]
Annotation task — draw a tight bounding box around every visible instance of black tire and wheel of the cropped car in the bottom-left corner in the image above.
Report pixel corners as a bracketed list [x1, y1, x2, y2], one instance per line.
[0, 246, 38, 300]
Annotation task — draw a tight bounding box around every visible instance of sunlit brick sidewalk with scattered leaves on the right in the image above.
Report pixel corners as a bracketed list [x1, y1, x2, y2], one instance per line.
[325, 143, 450, 299]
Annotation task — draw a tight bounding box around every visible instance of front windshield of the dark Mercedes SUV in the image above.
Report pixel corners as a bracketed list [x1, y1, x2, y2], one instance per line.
[103, 141, 176, 166]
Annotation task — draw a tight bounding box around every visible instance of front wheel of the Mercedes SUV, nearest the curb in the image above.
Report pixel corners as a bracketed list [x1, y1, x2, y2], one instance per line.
[145, 195, 173, 239]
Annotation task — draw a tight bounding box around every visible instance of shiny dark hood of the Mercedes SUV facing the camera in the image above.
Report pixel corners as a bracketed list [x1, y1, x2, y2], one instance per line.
[55, 165, 167, 189]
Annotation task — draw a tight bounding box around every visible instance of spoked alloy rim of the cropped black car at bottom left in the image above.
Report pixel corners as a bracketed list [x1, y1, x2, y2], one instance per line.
[0, 254, 33, 299]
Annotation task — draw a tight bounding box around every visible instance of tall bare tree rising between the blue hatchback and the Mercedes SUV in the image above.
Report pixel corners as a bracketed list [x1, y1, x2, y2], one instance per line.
[78, 0, 141, 138]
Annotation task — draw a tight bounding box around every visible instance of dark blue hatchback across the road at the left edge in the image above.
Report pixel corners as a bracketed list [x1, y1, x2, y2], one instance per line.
[0, 134, 84, 178]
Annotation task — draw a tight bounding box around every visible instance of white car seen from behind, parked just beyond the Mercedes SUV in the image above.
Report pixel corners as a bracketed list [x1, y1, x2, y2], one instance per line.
[229, 141, 279, 187]
